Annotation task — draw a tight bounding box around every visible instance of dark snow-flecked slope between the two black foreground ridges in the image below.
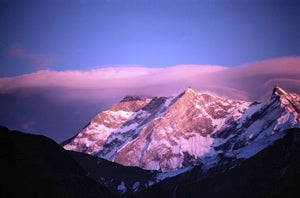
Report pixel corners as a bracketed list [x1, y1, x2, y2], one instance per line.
[68, 151, 159, 196]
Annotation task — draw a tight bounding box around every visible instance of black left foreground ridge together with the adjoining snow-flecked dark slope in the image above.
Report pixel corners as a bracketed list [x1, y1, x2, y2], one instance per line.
[0, 127, 182, 198]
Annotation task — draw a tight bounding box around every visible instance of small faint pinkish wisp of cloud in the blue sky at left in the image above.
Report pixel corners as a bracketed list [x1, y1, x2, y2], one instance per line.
[6, 44, 58, 70]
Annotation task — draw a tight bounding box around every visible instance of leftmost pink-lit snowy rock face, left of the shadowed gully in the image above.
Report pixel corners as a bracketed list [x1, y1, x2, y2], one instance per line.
[64, 97, 150, 154]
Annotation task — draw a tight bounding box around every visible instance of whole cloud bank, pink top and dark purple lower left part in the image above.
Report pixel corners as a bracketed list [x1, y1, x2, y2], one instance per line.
[0, 56, 300, 142]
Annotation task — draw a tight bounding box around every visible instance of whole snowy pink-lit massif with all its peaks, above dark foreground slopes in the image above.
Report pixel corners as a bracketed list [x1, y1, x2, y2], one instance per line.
[63, 85, 300, 172]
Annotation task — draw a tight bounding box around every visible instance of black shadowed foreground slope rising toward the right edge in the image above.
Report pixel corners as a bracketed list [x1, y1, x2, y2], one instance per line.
[136, 129, 300, 198]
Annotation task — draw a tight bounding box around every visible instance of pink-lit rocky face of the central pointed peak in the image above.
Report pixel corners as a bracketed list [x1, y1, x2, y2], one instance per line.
[114, 89, 247, 172]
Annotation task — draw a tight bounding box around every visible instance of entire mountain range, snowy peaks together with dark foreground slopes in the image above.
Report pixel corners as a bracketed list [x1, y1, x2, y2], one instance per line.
[0, 86, 300, 197]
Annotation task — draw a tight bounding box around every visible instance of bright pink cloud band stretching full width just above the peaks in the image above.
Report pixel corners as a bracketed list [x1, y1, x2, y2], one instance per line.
[0, 57, 300, 101]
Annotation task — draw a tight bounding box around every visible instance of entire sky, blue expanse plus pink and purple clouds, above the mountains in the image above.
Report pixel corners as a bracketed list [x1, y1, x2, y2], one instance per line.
[0, 0, 300, 142]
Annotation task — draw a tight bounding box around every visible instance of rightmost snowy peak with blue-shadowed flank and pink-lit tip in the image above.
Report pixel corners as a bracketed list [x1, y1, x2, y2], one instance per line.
[205, 86, 300, 169]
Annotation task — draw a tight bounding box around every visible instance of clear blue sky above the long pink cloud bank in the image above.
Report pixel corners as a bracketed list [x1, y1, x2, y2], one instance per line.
[0, 0, 300, 77]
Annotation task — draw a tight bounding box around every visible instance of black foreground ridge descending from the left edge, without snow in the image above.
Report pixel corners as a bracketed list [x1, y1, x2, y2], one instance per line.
[0, 127, 113, 198]
